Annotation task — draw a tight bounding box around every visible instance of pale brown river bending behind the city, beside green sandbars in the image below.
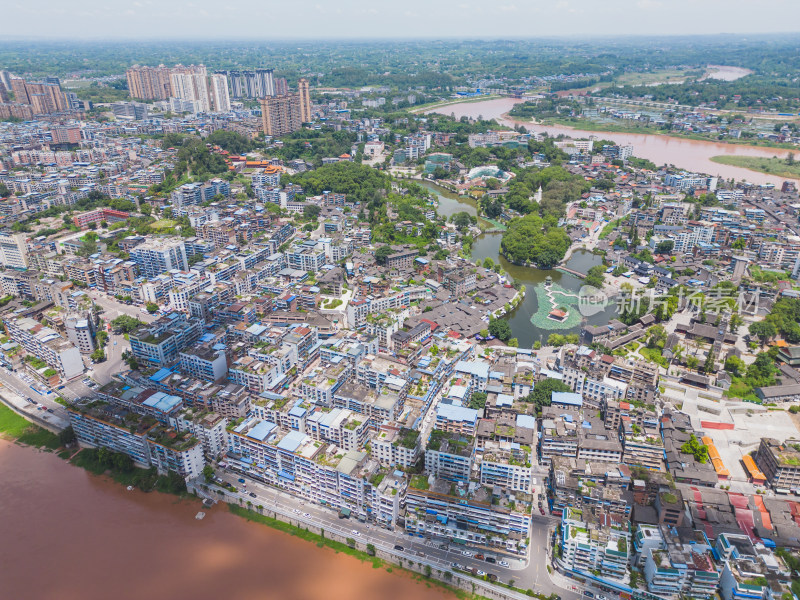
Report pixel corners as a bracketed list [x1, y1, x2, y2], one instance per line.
[428, 98, 789, 187]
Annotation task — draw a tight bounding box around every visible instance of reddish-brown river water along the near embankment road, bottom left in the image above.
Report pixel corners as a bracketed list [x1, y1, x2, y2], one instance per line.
[0, 440, 454, 600]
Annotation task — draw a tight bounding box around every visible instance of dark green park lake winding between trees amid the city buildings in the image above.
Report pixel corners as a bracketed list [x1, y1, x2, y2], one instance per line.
[421, 181, 616, 348]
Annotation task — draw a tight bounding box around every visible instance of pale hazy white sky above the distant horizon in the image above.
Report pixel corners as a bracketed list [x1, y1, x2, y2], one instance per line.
[6, 0, 800, 40]
